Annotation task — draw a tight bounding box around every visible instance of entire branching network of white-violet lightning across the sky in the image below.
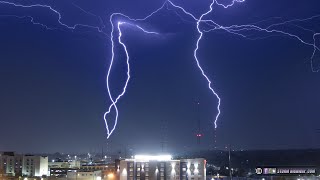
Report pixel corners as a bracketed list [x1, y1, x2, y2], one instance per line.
[0, 0, 320, 138]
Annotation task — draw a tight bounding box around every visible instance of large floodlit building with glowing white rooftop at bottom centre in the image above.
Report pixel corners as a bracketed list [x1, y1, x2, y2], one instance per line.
[117, 155, 206, 180]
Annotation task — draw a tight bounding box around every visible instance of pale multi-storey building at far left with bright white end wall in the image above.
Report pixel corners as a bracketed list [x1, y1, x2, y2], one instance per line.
[0, 152, 48, 177]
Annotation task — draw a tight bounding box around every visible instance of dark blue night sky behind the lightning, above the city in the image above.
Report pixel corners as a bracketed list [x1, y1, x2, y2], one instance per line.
[0, 0, 320, 152]
